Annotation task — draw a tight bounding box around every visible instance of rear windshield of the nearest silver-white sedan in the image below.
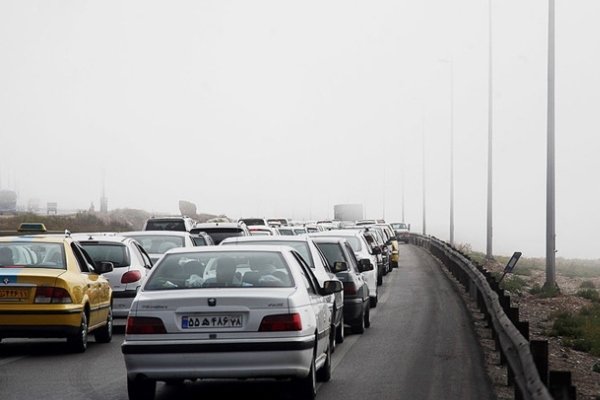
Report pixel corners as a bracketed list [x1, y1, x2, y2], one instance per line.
[144, 251, 294, 290]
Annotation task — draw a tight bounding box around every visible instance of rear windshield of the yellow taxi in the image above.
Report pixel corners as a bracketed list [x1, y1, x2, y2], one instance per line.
[0, 241, 67, 269]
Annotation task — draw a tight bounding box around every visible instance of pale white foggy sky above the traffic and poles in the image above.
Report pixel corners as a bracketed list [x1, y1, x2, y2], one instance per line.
[0, 0, 600, 258]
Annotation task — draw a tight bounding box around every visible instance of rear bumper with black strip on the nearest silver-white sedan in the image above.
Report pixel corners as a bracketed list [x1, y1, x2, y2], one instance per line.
[121, 337, 315, 380]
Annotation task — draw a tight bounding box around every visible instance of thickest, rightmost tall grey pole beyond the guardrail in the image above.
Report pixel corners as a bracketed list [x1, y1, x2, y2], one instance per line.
[544, 0, 556, 289]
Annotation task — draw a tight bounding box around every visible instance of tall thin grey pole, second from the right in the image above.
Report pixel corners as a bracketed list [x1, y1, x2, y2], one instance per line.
[485, 0, 494, 260]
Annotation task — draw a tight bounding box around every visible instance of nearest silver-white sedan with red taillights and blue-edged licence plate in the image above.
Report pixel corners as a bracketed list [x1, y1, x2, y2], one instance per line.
[122, 246, 342, 400]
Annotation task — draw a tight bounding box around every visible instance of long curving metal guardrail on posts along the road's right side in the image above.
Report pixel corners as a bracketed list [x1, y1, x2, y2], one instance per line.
[410, 234, 556, 400]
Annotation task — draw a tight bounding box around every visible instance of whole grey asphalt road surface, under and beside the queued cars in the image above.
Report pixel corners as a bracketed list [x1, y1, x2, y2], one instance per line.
[0, 245, 494, 400]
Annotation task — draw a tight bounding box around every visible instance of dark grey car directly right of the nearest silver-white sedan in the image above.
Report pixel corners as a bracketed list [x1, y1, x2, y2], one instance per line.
[312, 236, 374, 333]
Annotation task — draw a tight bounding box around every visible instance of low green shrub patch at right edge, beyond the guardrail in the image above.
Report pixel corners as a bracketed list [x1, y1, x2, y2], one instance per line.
[550, 304, 600, 357]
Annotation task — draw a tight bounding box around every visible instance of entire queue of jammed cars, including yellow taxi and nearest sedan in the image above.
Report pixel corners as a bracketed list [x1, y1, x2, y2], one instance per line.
[0, 217, 410, 400]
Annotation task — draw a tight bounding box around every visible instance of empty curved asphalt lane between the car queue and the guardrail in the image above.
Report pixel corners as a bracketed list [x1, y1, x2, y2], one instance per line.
[319, 245, 495, 400]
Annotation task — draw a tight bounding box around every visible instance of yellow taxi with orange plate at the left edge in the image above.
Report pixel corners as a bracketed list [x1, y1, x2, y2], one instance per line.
[0, 234, 113, 352]
